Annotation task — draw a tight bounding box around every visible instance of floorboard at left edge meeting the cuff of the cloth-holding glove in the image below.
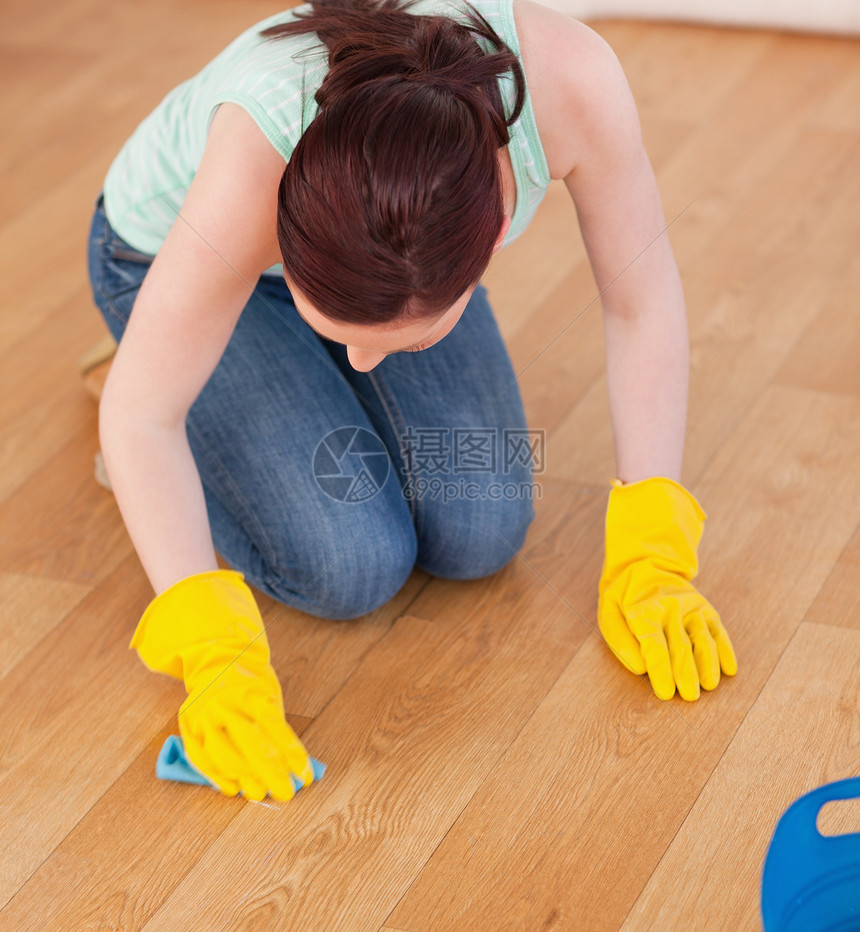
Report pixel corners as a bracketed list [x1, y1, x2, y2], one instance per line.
[0, 558, 156, 915]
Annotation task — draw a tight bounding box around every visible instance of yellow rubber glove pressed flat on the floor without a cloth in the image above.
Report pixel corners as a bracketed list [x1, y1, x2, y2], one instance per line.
[597, 477, 738, 701]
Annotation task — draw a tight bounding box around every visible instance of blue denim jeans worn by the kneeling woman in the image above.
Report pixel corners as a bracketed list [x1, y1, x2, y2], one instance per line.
[89, 197, 534, 618]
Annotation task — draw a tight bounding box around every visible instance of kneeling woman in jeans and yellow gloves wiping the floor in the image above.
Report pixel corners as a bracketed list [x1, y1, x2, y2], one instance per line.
[90, 0, 736, 799]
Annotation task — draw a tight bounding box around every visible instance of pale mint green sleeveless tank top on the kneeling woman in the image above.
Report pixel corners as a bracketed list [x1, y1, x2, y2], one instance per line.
[104, 0, 550, 275]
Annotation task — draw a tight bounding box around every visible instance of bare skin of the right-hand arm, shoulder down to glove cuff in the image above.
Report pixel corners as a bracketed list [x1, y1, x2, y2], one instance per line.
[526, 4, 689, 482]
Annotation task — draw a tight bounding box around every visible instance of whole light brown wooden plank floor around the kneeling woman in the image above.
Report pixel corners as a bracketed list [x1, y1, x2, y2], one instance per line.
[0, 0, 860, 932]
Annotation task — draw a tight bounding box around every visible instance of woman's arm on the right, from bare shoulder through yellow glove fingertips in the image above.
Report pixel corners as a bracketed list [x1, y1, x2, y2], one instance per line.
[518, 0, 737, 701]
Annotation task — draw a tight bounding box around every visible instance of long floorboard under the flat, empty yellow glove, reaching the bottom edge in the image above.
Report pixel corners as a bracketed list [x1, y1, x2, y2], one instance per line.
[390, 388, 860, 932]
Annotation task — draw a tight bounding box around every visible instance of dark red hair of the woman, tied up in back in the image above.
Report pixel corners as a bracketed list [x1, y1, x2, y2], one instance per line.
[263, 0, 525, 324]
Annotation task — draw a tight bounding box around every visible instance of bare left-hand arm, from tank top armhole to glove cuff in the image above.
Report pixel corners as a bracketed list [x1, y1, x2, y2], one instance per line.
[99, 104, 284, 594]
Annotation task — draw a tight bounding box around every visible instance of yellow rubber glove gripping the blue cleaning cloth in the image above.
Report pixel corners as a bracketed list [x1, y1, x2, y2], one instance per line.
[130, 570, 313, 800]
